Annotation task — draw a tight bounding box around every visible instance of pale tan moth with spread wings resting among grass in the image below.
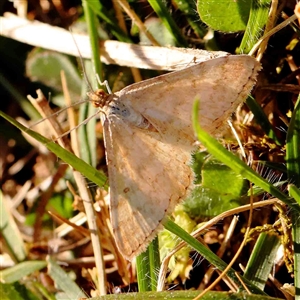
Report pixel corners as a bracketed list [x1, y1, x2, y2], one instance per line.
[90, 55, 260, 260]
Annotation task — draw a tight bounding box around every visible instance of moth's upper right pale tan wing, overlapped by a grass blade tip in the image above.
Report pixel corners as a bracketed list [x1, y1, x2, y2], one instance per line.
[116, 55, 260, 139]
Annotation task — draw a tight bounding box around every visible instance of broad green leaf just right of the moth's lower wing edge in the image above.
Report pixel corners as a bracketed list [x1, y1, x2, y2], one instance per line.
[184, 152, 248, 218]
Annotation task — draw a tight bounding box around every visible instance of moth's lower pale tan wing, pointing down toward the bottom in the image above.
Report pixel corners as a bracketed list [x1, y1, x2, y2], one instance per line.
[104, 116, 195, 260]
